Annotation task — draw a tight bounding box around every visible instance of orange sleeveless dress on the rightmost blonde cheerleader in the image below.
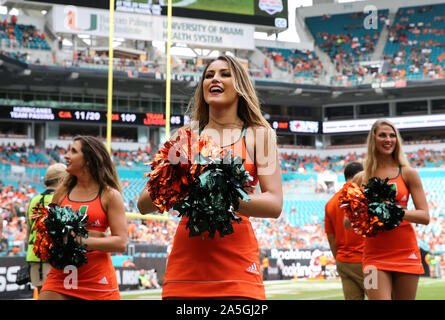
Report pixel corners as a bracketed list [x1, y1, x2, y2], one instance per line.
[363, 167, 424, 274]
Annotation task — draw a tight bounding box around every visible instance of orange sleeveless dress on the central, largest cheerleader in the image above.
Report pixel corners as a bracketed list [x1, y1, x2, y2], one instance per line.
[162, 129, 266, 300]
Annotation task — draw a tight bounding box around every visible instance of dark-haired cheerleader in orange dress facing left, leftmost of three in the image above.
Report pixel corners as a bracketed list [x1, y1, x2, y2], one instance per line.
[39, 136, 127, 300]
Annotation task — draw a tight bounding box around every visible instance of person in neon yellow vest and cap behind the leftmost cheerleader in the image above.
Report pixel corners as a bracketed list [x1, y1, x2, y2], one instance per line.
[26, 163, 67, 292]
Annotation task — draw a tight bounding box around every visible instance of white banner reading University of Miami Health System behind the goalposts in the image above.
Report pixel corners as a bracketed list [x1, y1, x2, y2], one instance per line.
[52, 5, 255, 50]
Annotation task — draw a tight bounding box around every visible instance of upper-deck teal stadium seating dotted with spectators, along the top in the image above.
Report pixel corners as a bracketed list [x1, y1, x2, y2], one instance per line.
[0, 4, 445, 87]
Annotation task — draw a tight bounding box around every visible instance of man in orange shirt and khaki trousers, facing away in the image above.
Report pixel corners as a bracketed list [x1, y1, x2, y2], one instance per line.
[325, 162, 365, 300]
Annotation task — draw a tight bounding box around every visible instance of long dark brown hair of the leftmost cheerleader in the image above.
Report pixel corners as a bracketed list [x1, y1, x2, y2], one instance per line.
[61, 136, 122, 193]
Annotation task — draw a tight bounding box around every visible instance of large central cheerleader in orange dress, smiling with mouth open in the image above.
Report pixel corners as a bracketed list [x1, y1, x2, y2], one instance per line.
[138, 56, 283, 299]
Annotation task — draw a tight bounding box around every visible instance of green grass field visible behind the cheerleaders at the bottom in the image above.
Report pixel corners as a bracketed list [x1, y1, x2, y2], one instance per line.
[121, 278, 445, 300]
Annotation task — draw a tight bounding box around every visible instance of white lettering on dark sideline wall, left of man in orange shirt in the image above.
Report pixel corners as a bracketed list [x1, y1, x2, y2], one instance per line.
[269, 249, 336, 279]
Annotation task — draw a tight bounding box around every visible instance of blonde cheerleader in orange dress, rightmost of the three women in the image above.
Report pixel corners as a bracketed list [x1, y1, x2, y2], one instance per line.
[345, 120, 430, 300]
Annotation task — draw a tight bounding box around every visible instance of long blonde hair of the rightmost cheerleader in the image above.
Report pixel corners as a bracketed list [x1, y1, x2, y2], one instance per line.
[362, 119, 410, 184]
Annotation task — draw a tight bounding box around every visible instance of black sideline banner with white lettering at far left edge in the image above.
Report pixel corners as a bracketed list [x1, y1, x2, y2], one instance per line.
[0, 257, 33, 299]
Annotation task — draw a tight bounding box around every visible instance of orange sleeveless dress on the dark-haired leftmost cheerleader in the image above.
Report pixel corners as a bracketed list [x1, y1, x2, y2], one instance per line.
[42, 191, 120, 300]
